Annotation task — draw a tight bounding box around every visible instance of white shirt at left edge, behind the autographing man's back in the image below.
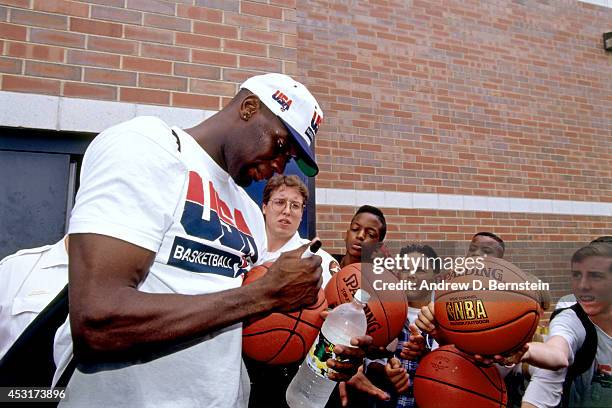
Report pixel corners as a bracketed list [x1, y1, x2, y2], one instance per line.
[0, 239, 68, 358]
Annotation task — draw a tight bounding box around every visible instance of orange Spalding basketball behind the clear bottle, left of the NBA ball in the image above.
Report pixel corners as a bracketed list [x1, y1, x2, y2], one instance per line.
[325, 263, 408, 347]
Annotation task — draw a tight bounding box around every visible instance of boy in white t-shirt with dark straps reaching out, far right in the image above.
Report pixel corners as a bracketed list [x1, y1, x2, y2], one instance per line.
[522, 243, 612, 408]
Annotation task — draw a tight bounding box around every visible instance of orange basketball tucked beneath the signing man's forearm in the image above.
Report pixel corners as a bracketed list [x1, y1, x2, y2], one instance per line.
[242, 263, 327, 364]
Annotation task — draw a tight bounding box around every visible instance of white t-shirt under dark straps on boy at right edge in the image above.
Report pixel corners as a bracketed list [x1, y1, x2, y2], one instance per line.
[523, 310, 612, 408]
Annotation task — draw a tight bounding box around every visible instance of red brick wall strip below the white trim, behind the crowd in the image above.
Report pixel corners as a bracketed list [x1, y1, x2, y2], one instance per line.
[317, 205, 612, 300]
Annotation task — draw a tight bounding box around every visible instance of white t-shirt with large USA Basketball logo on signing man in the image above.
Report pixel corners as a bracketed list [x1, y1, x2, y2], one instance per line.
[54, 117, 265, 408]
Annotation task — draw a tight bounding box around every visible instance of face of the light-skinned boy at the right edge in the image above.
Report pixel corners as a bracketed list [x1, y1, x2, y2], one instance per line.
[571, 256, 612, 316]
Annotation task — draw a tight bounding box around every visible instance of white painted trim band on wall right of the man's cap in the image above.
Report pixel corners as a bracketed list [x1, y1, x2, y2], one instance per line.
[316, 188, 612, 217]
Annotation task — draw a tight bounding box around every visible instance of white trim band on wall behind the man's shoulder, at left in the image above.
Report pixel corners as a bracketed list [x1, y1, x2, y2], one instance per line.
[0, 91, 215, 133]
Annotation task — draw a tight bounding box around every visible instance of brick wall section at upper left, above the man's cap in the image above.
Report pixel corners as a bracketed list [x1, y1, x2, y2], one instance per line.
[0, 0, 297, 110]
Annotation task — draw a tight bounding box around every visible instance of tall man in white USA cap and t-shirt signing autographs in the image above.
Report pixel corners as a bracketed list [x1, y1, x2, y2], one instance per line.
[54, 74, 371, 408]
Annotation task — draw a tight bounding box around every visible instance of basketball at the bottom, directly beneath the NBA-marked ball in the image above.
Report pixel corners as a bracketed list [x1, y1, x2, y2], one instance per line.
[414, 346, 508, 408]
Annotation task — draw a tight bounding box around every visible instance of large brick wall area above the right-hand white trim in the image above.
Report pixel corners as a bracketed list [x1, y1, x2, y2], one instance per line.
[298, 0, 612, 202]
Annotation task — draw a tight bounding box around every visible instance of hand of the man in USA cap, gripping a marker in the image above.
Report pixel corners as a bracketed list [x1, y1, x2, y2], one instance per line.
[253, 242, 323, 312]
